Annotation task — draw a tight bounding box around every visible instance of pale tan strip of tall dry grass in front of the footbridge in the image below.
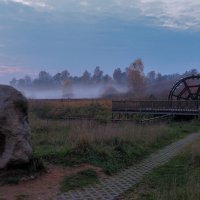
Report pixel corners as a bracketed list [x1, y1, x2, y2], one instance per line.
[69, 122, 167, 147]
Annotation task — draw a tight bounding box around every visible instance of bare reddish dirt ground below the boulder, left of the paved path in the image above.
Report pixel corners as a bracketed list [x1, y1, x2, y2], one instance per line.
[0, 164, 102, 200]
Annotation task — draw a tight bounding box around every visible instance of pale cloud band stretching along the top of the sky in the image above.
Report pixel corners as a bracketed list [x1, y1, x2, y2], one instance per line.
[3, 0, 200, 30]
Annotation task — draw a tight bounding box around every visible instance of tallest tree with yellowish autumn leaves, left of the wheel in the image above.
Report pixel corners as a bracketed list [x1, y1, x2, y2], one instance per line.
[127, 59, 145, 96]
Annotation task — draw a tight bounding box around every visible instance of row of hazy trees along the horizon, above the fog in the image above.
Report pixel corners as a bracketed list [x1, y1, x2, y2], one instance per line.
[10, 59, 198, 96]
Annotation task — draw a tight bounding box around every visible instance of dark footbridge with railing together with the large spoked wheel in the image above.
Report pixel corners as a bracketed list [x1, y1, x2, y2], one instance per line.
[112, 74, 200, 119]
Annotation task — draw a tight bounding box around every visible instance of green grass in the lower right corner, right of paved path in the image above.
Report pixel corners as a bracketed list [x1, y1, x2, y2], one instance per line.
[118, 135, 200, 200]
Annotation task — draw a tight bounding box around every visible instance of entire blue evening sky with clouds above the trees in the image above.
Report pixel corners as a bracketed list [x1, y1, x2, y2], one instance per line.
[0, 0, 200, 83]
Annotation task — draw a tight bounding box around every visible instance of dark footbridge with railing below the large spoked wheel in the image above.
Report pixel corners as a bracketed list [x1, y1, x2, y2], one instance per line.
[112, 100, 200, 118]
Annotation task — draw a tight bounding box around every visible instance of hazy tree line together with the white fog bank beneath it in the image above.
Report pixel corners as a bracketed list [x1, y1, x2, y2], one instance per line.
[10, 59, 198, 99]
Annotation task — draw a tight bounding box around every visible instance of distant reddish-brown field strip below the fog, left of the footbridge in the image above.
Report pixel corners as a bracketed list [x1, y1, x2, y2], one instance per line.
[29, 99, 112, 119]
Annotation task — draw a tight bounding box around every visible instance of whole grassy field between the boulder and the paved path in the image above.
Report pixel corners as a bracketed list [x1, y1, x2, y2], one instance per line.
[30, 100, 199, 174]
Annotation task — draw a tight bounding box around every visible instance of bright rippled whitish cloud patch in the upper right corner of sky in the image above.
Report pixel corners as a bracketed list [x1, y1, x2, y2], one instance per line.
[136, 0, 200, 29]
